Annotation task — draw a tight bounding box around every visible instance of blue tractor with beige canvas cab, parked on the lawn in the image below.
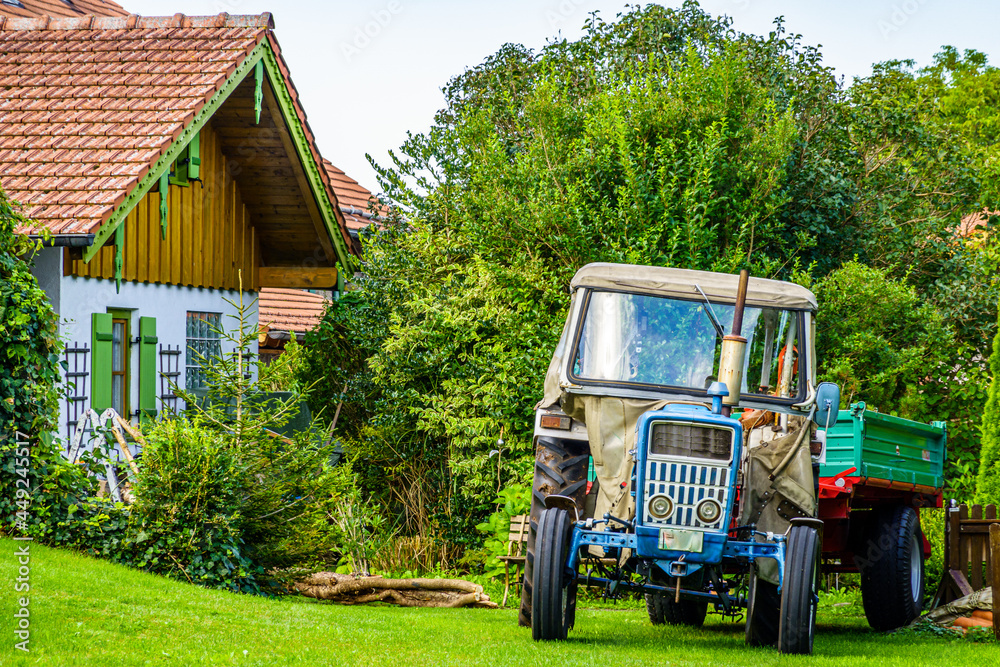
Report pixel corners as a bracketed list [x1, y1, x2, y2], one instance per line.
[521, 264, 839, 653]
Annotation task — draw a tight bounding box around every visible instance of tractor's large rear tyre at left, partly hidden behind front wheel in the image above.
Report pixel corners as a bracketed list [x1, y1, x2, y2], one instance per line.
[517, 437, 590, 628]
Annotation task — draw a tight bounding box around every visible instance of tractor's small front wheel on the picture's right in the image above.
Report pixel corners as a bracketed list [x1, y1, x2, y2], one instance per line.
[778, 525, 819, 655]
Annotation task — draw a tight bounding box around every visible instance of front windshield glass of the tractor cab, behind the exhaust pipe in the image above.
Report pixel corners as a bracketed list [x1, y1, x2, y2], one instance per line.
[571, 291, 802, 398]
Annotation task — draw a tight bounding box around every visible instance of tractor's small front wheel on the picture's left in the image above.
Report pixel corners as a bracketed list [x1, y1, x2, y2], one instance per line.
[531, 508, 577, 641]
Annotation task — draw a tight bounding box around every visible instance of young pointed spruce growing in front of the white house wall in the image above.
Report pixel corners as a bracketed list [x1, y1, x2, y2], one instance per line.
[163, 294, 348, 570]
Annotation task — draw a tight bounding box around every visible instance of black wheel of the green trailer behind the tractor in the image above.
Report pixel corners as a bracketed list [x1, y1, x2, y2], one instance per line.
[858, 505, 924, 631]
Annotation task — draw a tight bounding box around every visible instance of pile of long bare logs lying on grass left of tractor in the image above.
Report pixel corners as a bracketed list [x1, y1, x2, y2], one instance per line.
[295, 572, 498, 609]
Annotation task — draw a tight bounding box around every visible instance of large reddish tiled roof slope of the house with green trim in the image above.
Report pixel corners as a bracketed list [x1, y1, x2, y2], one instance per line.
[0, 14, 272, 234]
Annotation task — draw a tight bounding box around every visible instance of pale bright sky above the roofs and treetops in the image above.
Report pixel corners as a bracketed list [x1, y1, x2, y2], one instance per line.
[133, 0, 1000, 193]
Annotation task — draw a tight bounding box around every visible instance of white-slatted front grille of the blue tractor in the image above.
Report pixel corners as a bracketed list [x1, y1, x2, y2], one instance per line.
[642, 422, 733, 530]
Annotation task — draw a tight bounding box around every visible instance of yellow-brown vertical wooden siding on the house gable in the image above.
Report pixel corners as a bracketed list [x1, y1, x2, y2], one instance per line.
[64, 124, 266, 291]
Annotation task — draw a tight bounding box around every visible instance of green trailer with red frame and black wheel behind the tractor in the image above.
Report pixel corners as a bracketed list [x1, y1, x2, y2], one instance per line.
[818, 403, 947, 630]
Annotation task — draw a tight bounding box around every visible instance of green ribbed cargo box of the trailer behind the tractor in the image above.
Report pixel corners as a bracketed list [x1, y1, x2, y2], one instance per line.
[820, 403, 947, 489]
